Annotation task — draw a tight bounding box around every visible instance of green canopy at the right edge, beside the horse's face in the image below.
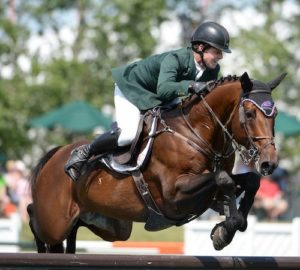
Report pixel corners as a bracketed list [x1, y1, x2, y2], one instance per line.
[275, 111, 300, 137]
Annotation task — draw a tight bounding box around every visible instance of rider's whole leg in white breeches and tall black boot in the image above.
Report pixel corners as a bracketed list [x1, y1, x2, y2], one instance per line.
[65, 85, 140, 181]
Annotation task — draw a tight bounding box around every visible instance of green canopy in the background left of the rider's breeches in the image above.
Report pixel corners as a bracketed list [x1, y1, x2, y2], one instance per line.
[29, 101, 112, 133]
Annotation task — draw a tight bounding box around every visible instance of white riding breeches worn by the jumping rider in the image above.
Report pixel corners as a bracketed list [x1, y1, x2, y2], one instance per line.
[114, 84, 141, 146]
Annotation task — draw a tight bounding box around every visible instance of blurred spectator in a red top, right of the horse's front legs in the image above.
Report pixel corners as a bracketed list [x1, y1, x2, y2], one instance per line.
[253, 168, 288, 220]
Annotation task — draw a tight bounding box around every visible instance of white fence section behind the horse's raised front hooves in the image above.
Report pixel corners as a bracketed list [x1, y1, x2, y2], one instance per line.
[184, 216, 300, 256]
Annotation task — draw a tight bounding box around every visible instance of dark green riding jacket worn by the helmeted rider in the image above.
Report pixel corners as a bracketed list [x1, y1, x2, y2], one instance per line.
[112, 47, 220, 110]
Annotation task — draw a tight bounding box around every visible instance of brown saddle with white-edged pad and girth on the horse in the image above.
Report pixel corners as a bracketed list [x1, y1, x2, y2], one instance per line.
[86, 107, 189, 231]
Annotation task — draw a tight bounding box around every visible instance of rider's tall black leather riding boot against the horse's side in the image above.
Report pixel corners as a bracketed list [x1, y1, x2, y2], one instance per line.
[64, 129, 120, 181]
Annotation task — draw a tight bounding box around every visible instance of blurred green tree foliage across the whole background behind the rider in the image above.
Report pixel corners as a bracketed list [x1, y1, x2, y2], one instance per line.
[0, 0, 300, 171]
